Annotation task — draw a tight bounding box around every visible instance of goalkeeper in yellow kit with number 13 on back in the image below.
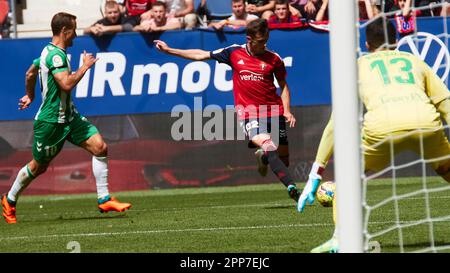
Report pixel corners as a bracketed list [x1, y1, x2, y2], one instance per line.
[297, 19, 450, 252]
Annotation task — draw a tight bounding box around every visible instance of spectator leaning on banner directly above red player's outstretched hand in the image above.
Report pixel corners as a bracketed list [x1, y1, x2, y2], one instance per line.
[133, 1, 182, 32]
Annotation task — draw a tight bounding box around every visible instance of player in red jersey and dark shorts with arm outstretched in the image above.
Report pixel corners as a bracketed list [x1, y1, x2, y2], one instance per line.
[155, 19, 299, 201]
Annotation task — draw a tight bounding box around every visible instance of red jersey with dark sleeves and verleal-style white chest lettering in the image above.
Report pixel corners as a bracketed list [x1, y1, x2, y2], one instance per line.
[210, 45, 286, 119]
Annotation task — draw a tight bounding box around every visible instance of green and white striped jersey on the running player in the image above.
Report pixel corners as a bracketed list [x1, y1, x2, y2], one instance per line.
[35, 43, 78, 123]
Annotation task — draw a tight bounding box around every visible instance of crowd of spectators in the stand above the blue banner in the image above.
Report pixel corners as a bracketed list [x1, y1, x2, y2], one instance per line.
[0, 0, 450, 38]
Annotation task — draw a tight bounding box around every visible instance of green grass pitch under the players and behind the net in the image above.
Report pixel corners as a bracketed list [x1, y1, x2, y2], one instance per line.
[0, 177, 450, 253]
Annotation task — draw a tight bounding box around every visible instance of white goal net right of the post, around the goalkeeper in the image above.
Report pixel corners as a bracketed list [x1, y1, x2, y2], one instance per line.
[356, 0, 450, 252]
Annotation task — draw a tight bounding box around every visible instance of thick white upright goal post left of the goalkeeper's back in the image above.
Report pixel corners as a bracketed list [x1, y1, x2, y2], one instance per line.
[329, 0, 363, 253]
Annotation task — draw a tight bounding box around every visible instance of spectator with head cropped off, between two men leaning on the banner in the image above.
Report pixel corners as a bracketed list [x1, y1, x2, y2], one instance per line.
[164, 0, 197, 30]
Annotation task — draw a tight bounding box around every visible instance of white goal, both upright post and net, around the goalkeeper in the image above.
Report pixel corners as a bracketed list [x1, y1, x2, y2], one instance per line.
[329, 0, 450, 253]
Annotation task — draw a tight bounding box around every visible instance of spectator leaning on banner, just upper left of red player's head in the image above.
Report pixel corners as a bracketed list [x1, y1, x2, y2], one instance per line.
[209, 0, 258, 30]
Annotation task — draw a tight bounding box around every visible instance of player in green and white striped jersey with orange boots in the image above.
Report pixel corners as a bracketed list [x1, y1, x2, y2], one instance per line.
[1, 12, 131, 224]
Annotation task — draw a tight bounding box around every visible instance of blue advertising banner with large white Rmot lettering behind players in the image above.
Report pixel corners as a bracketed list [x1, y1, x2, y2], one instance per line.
[0, 18, 449, 120]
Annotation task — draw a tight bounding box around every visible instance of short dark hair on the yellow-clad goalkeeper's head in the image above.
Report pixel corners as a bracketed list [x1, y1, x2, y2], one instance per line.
[366, 18, 397, 50]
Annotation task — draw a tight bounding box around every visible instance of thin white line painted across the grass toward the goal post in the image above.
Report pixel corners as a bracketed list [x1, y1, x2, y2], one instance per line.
[0, 223, 333, 241]
